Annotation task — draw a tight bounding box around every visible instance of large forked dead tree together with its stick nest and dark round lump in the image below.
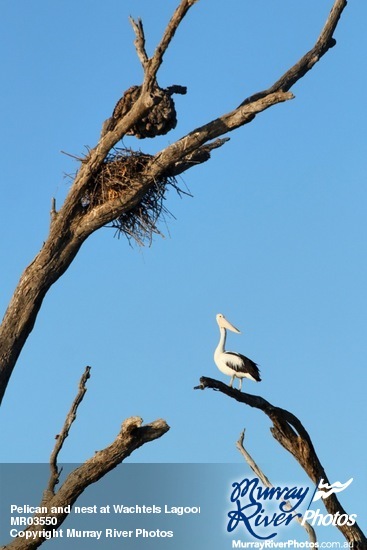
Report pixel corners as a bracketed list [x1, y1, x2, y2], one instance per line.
[0, 0, 347, 406]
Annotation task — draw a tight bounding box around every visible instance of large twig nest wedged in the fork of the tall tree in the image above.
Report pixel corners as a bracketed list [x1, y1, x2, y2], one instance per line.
[82, 149, 186, 245]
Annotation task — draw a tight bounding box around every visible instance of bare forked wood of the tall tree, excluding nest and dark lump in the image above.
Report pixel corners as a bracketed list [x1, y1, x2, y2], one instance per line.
[0, 0, 347, 406]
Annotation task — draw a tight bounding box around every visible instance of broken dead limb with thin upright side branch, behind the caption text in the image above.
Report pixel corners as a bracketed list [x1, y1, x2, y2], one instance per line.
[1, 367, 169, 550]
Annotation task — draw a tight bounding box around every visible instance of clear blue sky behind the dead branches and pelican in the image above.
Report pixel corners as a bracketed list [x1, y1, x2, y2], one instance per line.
[0, 0, 367, 540]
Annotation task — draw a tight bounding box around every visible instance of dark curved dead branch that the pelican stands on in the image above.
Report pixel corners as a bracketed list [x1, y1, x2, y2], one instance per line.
[195, 376, 367, 550]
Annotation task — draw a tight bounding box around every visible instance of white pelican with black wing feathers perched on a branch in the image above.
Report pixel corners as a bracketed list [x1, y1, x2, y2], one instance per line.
[214, 313, 261, 391]
